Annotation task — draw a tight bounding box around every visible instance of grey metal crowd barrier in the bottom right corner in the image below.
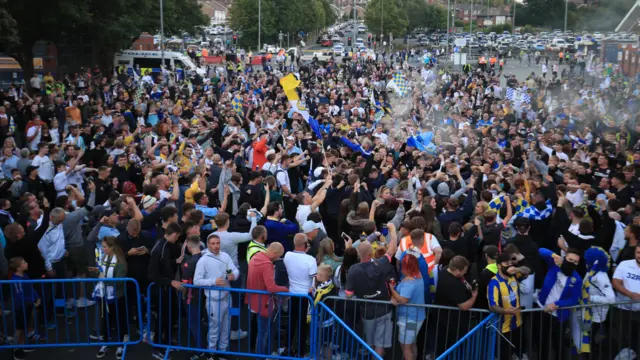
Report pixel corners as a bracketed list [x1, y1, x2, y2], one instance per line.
[496, 301, 640, 360]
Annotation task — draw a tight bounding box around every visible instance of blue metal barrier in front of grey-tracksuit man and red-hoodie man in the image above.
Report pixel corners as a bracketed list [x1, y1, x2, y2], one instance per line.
[147, 283, 316, 359]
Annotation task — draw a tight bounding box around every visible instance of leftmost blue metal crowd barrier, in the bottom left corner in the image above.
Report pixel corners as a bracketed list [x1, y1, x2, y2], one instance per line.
[0, 278, 142, 359]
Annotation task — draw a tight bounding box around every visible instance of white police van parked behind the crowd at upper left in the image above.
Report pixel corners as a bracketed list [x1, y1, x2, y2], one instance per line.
[113, 50, 206, 79]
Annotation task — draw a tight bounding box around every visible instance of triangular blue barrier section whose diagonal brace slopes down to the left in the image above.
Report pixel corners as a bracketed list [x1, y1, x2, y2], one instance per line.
[436, 314, 498, 360]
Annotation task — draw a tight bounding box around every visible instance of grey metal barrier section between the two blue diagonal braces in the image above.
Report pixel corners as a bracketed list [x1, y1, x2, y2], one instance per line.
[324, 297, 491, 359]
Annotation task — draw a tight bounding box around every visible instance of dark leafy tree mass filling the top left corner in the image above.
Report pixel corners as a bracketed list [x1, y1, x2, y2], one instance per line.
[0, 0, 208, 79]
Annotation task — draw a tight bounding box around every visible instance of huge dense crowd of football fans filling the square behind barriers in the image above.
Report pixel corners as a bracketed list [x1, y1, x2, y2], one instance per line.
[0, 43, 640, 360]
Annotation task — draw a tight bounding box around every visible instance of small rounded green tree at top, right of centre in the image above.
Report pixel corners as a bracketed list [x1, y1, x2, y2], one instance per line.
[364, 0, 409, 36]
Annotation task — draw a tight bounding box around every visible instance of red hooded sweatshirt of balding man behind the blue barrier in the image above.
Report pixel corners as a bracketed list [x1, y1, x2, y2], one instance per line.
[244, 252, 289, 317]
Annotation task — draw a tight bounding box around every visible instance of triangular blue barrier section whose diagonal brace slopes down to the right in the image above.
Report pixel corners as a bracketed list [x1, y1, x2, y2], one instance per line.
[312, 303, 382, 360]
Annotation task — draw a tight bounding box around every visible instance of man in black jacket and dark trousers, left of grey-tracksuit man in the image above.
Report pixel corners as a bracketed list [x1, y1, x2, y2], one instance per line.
[149, 223, 184, 358]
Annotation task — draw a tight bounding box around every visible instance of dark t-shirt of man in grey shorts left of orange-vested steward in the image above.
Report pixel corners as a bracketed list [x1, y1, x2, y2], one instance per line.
[346, 256, 395, 320]
